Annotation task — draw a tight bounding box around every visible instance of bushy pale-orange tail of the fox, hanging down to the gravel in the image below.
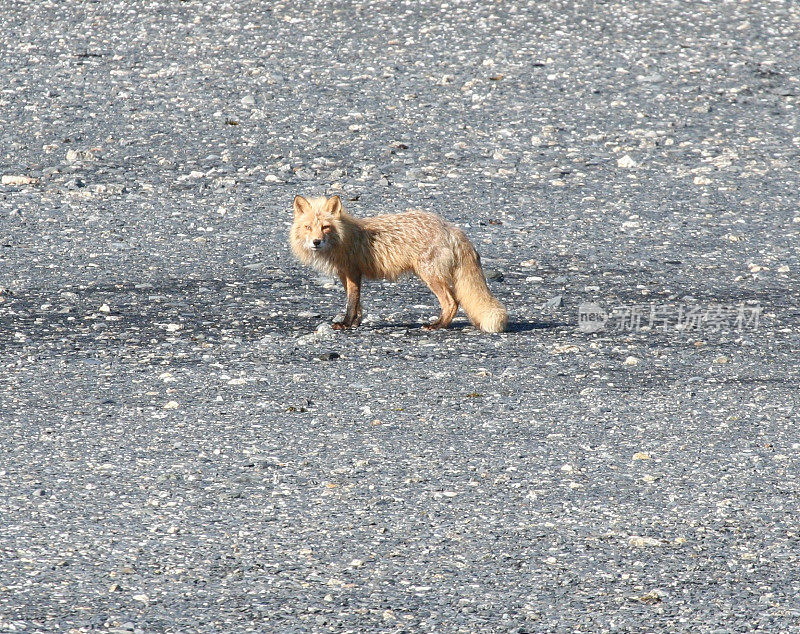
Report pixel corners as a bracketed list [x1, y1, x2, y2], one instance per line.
[453, 248, 508, 332]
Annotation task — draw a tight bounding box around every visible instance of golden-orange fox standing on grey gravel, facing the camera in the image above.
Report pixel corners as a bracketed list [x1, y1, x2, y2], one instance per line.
[289, 196, 508, 333]
